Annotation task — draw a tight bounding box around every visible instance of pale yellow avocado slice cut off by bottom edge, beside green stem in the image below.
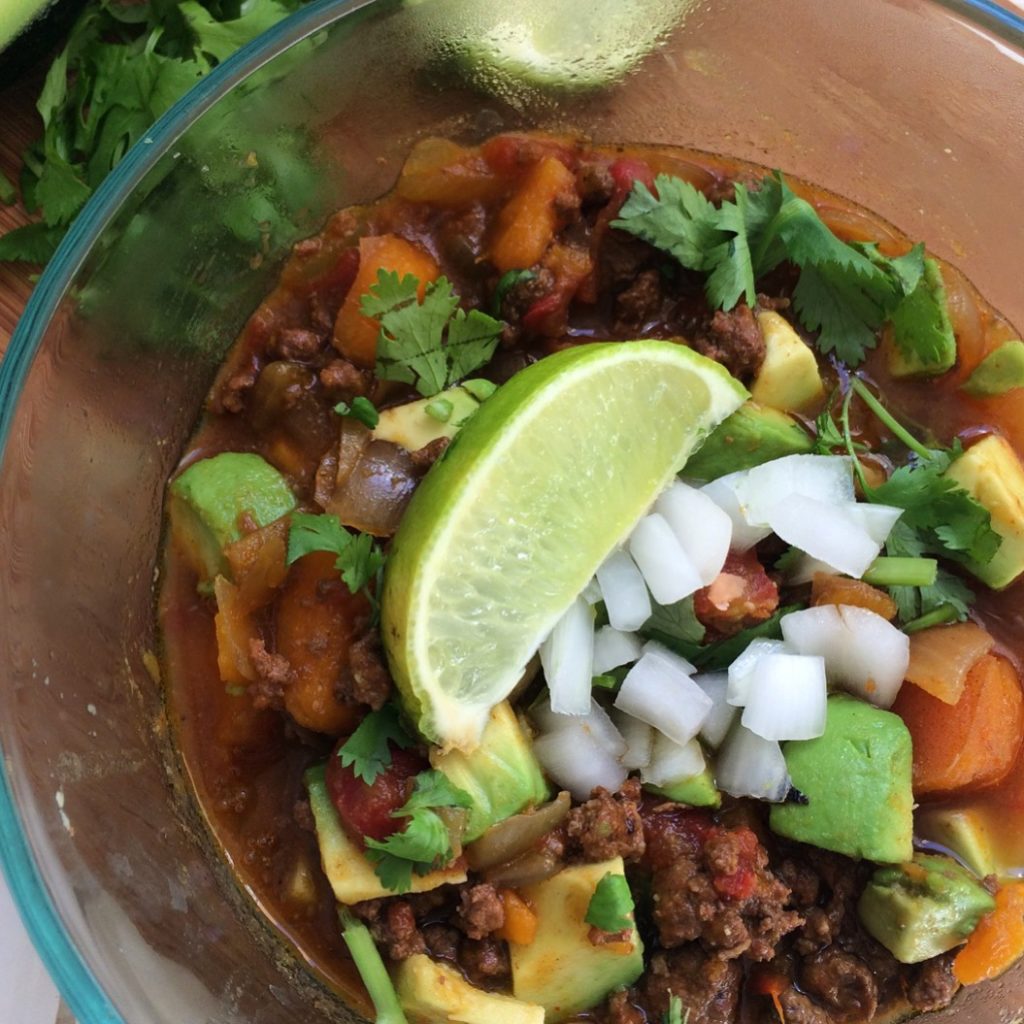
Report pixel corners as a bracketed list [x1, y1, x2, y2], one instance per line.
[394, 953, 544, 1024]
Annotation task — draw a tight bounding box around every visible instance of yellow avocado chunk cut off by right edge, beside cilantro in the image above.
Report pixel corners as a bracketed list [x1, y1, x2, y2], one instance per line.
[945, 434, 1024, 590]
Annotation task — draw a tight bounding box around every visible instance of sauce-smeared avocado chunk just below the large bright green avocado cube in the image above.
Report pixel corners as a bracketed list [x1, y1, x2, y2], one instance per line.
[857, 853, 995, 964]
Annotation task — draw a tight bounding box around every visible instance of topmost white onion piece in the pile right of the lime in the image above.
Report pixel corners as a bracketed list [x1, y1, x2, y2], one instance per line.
[736, 455, 854, 528]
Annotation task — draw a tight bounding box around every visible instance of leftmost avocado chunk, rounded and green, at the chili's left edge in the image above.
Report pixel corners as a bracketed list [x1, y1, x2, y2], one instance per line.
[168, 452, 296, 581]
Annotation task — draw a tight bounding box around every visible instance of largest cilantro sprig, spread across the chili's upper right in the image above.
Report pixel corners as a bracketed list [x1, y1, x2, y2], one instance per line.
[612, 171, 930, 366]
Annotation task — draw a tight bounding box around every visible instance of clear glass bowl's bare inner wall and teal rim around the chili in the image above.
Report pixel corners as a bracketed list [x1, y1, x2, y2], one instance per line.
[0, 0, 1024, 1024]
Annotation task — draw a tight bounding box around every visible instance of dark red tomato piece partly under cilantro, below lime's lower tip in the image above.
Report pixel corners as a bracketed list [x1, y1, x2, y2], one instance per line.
[327, 740, 428, 840]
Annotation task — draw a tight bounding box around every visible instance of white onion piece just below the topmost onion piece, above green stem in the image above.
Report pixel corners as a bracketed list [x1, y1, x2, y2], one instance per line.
[768, 497, 882, 579]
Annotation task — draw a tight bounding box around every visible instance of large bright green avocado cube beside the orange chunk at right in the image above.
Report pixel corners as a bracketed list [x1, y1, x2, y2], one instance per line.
[769, 695, 913, 863]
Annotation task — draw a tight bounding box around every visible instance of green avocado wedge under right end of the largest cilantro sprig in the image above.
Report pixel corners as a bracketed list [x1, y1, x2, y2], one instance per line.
[889, 259, 956, 377]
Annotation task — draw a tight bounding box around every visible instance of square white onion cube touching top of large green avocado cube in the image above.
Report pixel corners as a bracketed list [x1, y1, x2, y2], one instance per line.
[740, 654, 828, 739]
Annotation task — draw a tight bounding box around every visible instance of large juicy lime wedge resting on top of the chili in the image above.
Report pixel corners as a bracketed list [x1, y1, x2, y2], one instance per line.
[381, 341, 746, 750]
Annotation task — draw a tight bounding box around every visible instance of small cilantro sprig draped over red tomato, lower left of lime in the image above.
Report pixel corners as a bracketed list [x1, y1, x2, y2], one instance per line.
[366, 770, 472, 893]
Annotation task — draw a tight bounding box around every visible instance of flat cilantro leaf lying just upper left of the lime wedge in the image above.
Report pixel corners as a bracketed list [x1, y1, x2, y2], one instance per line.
[359, 269, 504, 398]
